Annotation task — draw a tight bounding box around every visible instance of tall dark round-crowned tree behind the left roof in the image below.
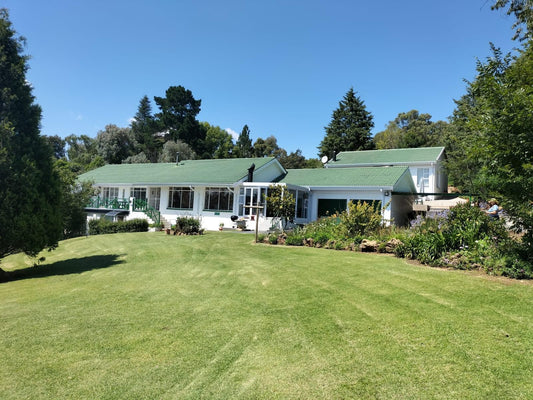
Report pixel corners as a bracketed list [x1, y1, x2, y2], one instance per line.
[154, 86, 205, 154]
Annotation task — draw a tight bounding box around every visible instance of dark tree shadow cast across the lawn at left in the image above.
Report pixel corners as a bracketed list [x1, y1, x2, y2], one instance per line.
[0, 254, 124, 283]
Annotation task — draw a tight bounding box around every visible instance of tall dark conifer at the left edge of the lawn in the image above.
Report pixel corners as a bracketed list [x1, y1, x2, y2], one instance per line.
[0, 9, 61, 258]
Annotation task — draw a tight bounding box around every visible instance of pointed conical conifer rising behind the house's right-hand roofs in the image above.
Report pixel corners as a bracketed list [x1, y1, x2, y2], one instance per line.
[318, 88, 374, 157]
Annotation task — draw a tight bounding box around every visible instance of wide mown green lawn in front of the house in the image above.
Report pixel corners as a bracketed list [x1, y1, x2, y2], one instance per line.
[0, 232, 533, 399]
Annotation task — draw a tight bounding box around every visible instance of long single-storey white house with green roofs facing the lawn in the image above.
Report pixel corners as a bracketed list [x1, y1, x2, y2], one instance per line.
[79, 157, 416, 231]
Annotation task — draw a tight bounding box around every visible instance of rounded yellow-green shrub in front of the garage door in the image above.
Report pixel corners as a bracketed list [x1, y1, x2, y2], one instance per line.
[339, 201, 382, 237]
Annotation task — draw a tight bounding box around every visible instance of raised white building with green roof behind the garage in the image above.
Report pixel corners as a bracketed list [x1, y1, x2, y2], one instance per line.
[325, 147, 448, 200]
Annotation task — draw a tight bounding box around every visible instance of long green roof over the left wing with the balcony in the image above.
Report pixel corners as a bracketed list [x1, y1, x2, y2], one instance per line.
[78, 157, 275, 185]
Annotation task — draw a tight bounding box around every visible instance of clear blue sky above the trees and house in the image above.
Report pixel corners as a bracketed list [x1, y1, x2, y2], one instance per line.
[0, 0, 518, 157]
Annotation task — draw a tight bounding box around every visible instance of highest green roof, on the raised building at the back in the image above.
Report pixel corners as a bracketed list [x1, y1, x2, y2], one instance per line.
[327, 147, 444, 167]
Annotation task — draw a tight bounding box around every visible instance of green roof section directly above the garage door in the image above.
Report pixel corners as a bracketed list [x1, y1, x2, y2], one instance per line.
[280, 167, 409, 187]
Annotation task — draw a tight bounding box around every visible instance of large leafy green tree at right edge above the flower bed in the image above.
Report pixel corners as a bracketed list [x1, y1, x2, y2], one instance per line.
[449, 43, 533, 262]
